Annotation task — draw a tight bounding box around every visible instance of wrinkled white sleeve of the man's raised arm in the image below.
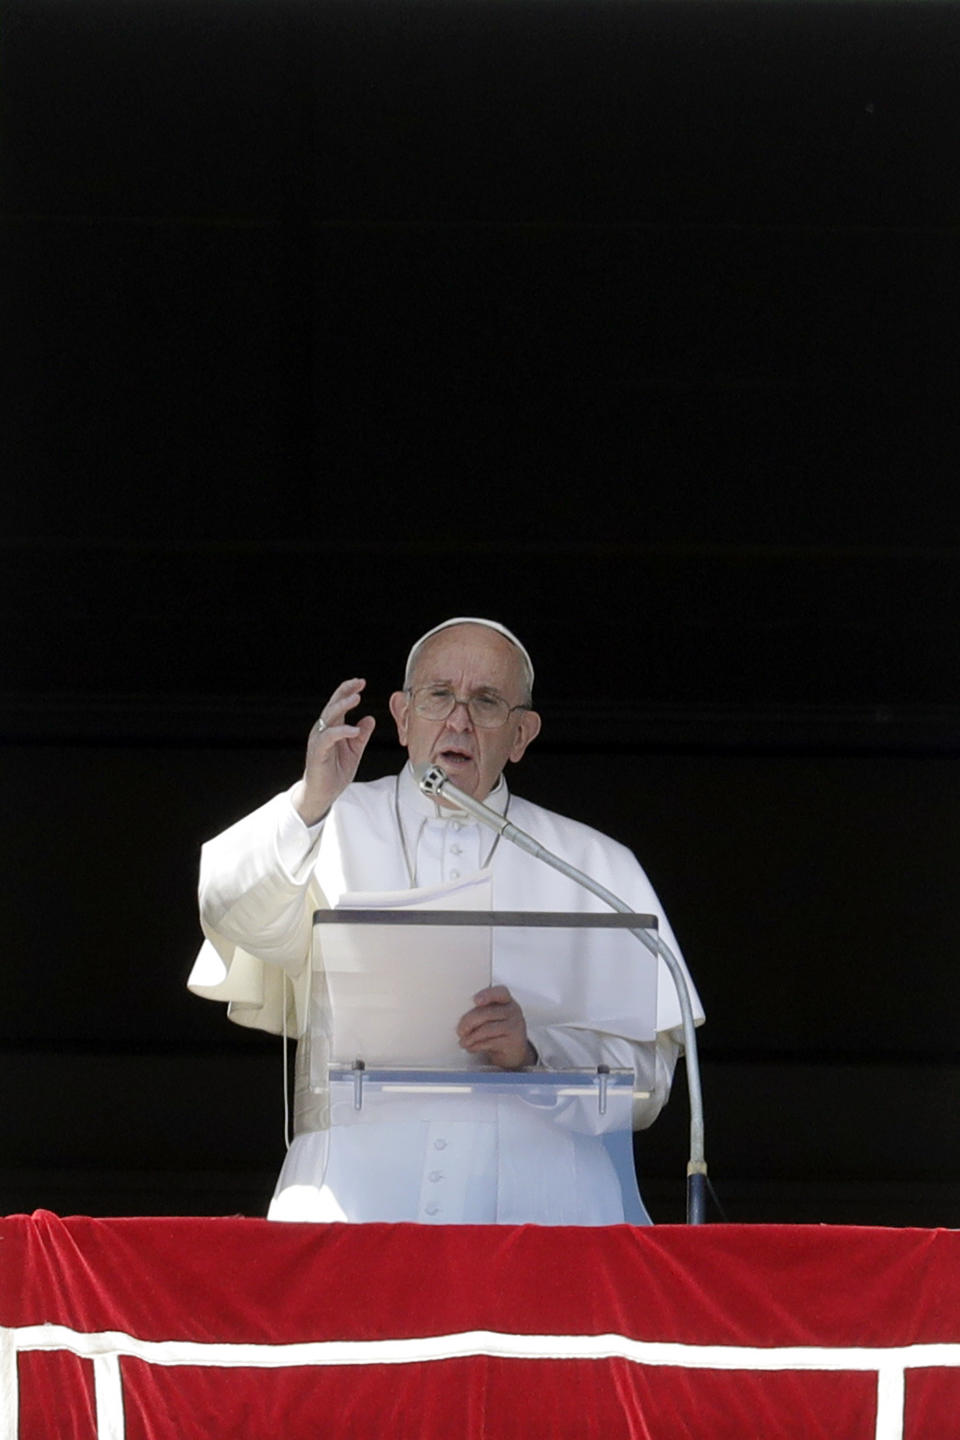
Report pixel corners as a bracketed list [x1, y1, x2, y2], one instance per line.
[200, 793, 322, 973]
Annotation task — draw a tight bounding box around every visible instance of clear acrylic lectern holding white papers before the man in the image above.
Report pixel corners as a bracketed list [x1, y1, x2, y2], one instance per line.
[309, 906, 658, 1224]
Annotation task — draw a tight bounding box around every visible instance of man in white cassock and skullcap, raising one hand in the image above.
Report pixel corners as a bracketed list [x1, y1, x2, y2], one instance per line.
[190, 618, 702, 1225]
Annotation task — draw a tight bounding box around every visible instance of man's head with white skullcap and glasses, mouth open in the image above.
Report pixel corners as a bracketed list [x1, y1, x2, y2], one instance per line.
[390, 625, 540, 801]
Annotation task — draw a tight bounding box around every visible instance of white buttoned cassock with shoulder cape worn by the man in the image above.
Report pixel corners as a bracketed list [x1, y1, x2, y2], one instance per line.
[189, 765, 702, 1225]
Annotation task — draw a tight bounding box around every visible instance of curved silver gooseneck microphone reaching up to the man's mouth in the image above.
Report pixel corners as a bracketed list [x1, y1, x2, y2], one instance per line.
[415, 765, 707, 1225]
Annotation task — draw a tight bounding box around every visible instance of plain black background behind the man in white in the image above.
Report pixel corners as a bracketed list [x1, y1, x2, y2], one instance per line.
[0, 0, 960, 1225]
